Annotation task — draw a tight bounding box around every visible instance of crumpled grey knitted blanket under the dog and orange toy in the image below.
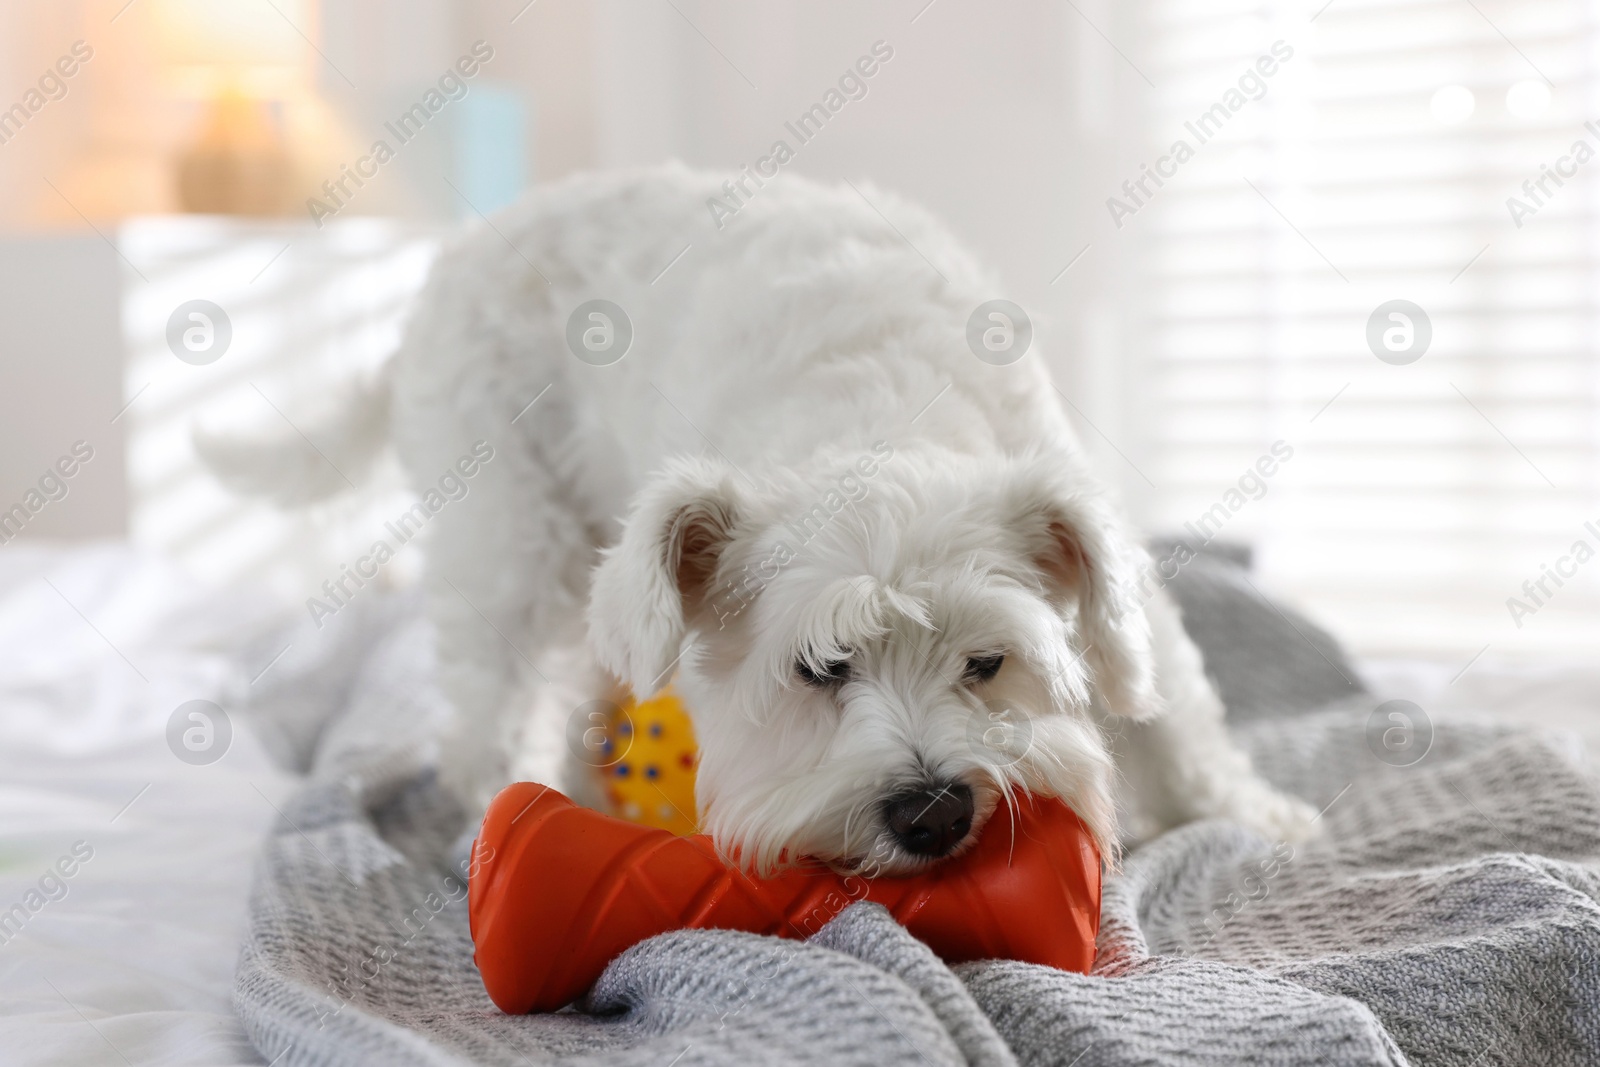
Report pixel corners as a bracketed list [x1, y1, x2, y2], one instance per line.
[235, 558, 1600, 1067]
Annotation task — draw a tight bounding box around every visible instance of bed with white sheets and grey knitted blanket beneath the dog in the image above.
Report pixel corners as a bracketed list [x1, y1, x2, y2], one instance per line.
[0, 544, 1600, 1067]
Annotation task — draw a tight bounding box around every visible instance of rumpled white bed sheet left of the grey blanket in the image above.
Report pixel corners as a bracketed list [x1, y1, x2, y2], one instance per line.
[0, 544, 294, 1067]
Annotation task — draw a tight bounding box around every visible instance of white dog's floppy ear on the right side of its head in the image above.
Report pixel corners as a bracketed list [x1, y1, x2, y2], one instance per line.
[1011, 461, 1162, 718]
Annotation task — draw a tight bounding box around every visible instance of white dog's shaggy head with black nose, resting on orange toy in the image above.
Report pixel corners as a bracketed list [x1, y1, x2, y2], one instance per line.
[589, 443, 1157, 873]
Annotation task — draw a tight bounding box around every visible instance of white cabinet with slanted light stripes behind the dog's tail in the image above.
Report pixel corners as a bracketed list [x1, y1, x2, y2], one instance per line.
[118, 216, 438, 603]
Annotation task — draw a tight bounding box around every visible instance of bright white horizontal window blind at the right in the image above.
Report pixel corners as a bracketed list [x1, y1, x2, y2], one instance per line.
[1122, 0, 1600, 661]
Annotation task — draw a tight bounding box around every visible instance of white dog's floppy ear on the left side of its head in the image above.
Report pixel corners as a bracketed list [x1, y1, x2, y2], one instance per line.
[589, 459, 739, 699]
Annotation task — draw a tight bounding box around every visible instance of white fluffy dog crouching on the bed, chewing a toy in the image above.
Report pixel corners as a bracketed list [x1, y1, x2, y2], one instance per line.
[211, 166, 1310, 873]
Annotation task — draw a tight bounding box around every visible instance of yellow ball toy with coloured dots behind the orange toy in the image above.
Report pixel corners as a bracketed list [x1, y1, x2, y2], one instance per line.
[597, 686, 699, 837]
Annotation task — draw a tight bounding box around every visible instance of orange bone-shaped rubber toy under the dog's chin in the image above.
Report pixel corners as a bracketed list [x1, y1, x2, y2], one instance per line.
[469, 782, 1101, 1014]
